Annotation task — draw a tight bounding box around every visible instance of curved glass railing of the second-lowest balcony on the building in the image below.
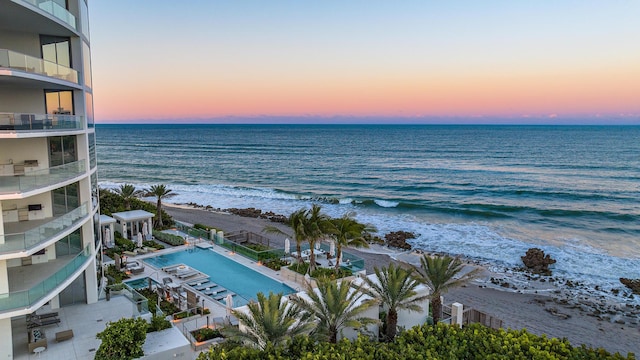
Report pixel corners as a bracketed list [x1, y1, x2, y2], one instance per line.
[0, 203, 89, 254]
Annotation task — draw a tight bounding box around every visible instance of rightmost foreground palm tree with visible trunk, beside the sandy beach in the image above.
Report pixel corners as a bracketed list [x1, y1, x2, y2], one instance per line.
[413, 255, 480, 324]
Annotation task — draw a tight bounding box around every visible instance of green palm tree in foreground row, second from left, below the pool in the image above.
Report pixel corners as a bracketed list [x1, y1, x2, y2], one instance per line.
[289, 278, 375, 344]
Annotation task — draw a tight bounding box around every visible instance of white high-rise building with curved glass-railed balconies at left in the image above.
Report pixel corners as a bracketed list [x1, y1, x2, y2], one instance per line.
[0, 0, 101, 359]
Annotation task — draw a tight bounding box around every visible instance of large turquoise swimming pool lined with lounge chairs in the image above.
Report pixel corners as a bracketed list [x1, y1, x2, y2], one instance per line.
[144, 248, 295, 306]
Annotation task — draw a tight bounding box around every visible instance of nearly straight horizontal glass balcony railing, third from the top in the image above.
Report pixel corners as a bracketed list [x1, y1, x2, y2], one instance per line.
[0, 112, 85, 132]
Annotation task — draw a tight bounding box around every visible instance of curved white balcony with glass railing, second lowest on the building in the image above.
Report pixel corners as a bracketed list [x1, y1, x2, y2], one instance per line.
[0, 203, 89, 258]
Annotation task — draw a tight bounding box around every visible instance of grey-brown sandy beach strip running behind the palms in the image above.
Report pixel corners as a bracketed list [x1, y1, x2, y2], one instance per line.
[163, 203, 640, 355]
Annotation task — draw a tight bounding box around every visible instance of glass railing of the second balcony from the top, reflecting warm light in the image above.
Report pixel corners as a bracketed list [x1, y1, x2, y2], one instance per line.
[0, 49, 79, 84]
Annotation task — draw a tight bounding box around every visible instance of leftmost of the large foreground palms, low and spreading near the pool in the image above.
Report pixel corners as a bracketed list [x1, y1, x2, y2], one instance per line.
[225, 292, 313, 349]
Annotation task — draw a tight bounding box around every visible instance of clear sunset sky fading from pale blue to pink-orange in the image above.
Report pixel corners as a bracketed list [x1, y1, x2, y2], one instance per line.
[89, 0, 640, 124]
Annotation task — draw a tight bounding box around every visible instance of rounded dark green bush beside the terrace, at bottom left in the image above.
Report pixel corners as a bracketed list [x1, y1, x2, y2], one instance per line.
[95, 318, 148, 360]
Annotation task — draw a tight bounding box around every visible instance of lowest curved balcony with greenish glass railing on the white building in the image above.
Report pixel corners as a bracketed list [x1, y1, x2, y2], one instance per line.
[0, 245, 92, 312]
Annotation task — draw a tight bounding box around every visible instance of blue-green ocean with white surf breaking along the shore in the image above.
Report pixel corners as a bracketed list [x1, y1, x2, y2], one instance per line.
[96, 125, 640, 300]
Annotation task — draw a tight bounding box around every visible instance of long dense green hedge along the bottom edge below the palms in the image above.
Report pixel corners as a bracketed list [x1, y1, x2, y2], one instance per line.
[198, 324, 635, 360]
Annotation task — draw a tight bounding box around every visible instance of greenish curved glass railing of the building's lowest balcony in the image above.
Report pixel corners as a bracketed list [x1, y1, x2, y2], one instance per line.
[0, 245, 91, 311]
